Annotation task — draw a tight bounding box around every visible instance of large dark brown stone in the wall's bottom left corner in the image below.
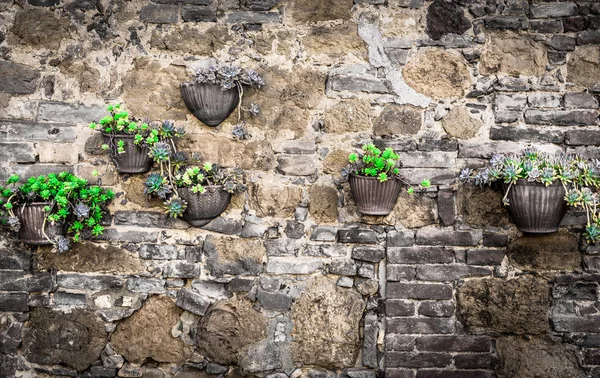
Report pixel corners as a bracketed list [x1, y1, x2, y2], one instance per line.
[23, 308, 107, 370]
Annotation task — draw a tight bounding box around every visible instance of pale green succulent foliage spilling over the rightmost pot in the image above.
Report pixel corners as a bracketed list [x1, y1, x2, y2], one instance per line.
[459, 148, 600, 243]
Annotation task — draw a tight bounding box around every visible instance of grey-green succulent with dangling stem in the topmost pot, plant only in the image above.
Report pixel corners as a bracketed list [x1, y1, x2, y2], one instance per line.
[194, 64, 265, 135]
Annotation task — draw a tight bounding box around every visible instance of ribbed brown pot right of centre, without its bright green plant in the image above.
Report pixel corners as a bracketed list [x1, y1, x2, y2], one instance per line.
[349, 173, 402, 215]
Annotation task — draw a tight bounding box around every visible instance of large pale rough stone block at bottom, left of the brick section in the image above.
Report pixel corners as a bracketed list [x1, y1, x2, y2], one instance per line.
[291, 276, 365, 369]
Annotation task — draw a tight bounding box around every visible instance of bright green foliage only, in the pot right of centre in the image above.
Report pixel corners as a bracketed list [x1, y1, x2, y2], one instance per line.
[342, 143, 431, 194]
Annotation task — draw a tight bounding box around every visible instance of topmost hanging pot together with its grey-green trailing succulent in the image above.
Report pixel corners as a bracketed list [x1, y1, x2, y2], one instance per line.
[181, 64, 265, 131]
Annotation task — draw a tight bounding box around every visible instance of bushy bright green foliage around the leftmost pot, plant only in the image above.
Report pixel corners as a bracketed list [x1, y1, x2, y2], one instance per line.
[0, 172, 114, 252]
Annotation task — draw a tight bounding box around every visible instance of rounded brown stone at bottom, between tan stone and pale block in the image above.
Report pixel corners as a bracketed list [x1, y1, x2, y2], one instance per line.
[196, 298, 267, 364]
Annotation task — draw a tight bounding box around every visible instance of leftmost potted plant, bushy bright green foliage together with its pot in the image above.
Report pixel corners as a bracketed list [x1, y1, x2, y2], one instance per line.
[0, 172, 114, 253]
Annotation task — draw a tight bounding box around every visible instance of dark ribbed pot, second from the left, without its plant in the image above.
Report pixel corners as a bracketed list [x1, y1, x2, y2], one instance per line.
[102, 133, 152, 173]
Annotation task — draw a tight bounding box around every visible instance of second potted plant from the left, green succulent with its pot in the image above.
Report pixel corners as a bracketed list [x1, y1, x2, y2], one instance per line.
[89, 104, 185, 173]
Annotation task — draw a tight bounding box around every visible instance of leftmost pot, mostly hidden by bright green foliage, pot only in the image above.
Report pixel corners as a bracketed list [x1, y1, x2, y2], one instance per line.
[13, 202, 65, 245]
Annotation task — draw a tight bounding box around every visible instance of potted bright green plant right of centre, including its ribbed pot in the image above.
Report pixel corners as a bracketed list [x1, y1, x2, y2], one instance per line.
[342, 143, 431, 215]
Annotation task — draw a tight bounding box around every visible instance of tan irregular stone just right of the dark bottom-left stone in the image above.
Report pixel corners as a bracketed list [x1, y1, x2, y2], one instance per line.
[110, 296, 192, 363]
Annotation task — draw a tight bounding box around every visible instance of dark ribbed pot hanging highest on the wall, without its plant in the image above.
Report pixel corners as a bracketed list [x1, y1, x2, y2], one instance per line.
[180, 82, 240, 126]
